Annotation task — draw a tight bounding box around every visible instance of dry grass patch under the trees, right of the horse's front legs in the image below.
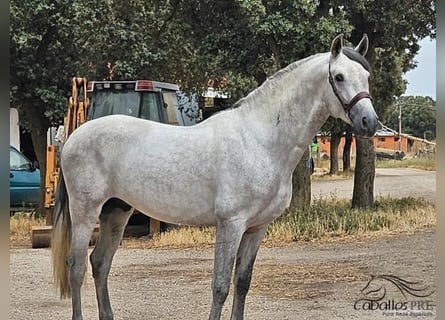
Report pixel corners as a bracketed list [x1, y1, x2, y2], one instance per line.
[265, 197, 436, 244]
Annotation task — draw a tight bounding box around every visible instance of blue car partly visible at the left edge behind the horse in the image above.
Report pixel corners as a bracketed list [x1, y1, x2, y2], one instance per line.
[9, 146, 40, 209]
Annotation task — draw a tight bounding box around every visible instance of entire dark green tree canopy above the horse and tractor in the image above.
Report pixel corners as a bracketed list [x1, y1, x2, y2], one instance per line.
[10, 0, 435, 132]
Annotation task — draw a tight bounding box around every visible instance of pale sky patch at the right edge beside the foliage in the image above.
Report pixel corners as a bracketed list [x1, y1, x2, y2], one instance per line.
[403, 38, 436, 100]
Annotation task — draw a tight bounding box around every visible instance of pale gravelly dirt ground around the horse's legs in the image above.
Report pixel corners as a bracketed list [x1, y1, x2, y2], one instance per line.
[9, 169, 436, 320]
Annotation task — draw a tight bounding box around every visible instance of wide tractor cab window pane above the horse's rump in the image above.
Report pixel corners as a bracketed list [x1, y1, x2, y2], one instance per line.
[88, 91, 140, 119]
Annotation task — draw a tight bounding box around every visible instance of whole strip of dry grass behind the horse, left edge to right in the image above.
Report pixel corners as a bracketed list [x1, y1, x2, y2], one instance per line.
[9, 197, 436, 248]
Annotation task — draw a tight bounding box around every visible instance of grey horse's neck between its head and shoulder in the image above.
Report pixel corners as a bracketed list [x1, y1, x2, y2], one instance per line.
[236, 54, 329, 163]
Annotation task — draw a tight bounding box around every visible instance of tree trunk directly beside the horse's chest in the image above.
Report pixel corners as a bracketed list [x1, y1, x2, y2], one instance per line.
[289, 148, 311, 212]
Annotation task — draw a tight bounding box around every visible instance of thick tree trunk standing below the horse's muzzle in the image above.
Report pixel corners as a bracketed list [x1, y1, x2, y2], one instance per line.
[352, 137, 375, 208]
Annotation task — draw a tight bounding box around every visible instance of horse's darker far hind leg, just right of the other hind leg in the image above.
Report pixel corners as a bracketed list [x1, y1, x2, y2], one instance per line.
[90, 199, 133, 320]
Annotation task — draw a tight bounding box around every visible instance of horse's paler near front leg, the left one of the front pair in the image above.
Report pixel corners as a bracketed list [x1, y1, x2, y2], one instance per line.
[209, 221, 245, 320]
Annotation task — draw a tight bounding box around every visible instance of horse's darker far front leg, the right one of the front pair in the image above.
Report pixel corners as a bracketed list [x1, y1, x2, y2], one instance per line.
[231, 225, 267, 320]
